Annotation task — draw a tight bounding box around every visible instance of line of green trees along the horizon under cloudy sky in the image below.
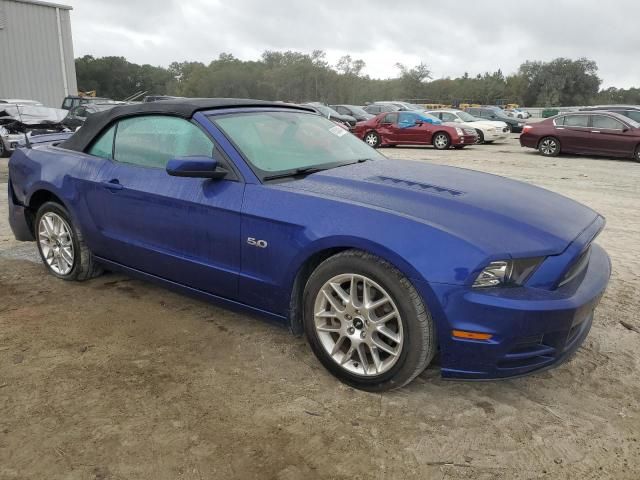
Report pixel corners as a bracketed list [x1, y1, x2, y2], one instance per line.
[76, 50, 640, 107]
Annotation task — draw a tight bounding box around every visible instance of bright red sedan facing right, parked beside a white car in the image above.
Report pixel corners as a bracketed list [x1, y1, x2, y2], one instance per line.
[353, 112, 477, 150]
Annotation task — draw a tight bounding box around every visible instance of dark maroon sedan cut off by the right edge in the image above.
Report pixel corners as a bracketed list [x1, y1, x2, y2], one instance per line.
[520, 112, 640, 162]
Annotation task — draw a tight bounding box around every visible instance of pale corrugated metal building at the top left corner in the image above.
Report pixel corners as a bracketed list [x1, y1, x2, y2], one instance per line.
[0, 0, 78, 108]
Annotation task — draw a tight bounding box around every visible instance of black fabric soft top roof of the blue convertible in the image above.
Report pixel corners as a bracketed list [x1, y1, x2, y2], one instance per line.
[59, 98, 315, 152]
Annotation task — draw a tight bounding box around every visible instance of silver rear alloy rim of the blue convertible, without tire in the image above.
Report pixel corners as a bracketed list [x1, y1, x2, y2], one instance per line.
[38, 212, 75, 275]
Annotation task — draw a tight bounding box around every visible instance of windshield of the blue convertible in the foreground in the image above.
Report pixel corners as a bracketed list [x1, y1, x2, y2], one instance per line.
[210, 111, 384, 180]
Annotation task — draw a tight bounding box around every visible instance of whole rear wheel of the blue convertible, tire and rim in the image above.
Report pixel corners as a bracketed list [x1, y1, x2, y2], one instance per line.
[34, 202, 103, 281]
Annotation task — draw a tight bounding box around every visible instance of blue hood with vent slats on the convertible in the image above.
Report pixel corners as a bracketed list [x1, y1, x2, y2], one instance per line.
[277, 159, 598, 257]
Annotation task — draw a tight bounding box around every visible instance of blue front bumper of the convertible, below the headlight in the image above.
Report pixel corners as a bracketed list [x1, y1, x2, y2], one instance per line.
[420, 244, 611, 380]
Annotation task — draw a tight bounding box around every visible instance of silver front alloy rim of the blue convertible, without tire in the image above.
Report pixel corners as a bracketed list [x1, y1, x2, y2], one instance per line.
[314, 273, 404, 377]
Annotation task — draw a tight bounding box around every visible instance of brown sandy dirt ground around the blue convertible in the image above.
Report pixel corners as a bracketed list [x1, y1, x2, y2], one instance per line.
[0, 139, 640, 480]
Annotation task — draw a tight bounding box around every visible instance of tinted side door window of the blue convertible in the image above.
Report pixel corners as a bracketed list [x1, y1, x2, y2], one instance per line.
[114, 115, 213, 168]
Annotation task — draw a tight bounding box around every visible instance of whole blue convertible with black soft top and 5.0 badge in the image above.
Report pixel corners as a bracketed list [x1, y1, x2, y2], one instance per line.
[9, 99, 611, 391]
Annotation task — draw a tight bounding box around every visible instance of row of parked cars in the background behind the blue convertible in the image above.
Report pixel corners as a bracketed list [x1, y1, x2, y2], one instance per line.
[0, 96, 640, 161]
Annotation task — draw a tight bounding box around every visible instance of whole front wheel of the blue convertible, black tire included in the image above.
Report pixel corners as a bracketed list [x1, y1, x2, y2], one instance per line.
[303, 250, 436, 392]
